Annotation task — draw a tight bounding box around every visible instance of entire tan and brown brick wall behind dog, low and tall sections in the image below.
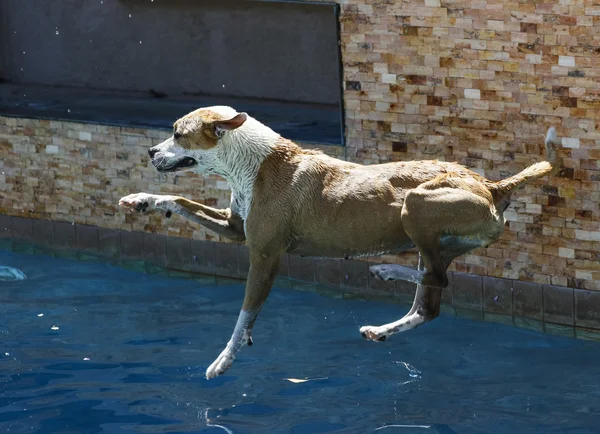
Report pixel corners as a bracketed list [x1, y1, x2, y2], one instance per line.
[0, 0, 600, 290]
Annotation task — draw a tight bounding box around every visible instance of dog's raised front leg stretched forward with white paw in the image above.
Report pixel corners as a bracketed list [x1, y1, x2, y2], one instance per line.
[119, 193, 246, 242]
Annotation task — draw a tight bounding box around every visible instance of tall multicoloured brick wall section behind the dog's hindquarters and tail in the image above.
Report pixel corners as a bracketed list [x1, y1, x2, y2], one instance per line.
[330, 0, 600, 290]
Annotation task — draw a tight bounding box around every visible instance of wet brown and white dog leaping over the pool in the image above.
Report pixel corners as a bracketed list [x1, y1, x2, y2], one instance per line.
[119, 106, 557, 379]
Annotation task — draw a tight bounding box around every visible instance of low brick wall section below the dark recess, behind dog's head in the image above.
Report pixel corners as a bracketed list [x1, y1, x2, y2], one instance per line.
[0, 116, 343, 242]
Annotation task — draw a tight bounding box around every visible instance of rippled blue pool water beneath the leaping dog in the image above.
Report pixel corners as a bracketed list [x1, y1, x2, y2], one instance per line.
[0, 252, 600, 434]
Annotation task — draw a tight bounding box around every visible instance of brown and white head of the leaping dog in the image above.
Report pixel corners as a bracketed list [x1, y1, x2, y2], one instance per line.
[148, 106, 248, 172]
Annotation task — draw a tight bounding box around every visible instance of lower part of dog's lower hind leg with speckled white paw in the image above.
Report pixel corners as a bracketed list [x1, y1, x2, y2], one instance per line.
[360, 255, 442, 342]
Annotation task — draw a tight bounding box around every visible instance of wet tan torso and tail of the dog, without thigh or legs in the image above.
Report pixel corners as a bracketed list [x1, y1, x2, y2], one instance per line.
[247, 127, 556, 257]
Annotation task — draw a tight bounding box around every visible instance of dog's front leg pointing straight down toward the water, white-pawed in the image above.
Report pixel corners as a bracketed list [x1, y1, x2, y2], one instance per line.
[206, 253, 279, 380]
